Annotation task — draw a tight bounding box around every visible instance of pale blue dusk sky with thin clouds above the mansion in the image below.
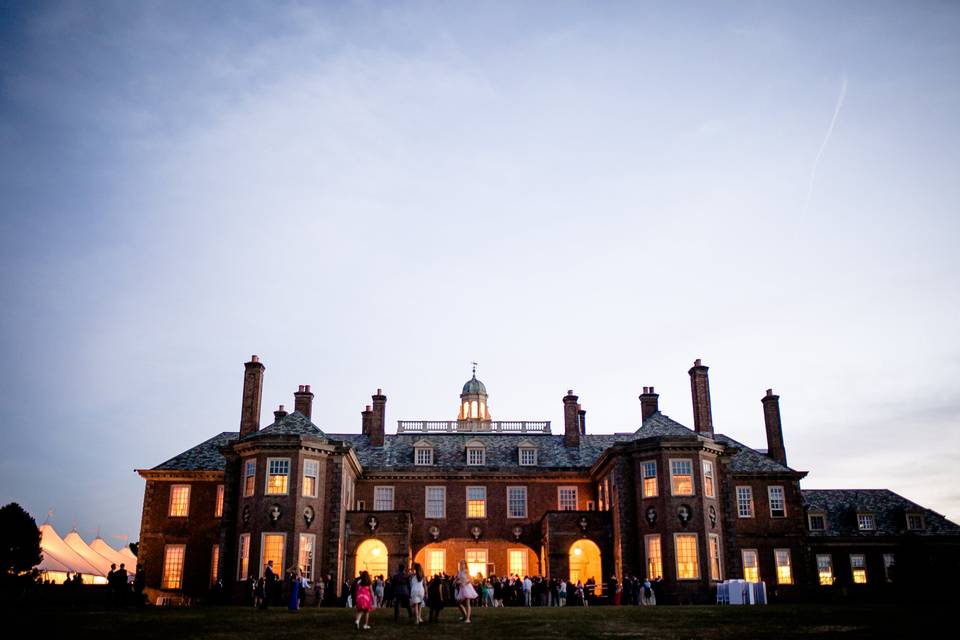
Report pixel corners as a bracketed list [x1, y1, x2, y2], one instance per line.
[0, 0, 960, 546]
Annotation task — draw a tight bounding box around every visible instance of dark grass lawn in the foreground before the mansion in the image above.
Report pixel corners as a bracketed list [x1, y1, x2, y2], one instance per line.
[22, 605, 952, 640]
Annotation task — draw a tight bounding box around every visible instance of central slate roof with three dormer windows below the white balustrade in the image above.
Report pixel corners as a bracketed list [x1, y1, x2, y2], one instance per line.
[328, 433, 630, 471]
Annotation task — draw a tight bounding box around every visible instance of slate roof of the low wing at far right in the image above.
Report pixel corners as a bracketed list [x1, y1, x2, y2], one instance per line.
[801, 489, 960, 538]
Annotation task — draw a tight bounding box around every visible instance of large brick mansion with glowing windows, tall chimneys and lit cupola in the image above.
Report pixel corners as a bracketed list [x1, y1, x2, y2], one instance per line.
[139, 356, 960, 602]
